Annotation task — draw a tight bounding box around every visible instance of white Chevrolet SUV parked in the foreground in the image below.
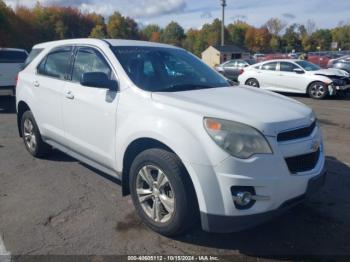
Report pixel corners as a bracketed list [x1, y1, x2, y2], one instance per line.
[17, 39, 325, 235]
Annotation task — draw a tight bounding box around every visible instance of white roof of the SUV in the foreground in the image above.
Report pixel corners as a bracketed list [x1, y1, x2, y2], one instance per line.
[34, 38, 178, 48]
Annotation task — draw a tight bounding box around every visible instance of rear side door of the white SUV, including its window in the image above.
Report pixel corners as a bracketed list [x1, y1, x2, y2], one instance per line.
[32, 46, 73, 144]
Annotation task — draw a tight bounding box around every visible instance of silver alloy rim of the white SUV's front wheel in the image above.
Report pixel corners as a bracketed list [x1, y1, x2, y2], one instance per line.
[136, 165, 175, 223]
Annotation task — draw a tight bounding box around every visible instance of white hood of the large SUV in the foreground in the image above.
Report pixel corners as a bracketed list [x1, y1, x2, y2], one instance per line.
[152, 87, 314, 136]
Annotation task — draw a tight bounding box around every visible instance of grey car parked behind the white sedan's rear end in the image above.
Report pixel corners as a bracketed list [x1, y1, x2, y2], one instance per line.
[215, 59, 256, 81]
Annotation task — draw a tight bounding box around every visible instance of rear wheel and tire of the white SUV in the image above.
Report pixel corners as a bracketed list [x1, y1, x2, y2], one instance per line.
[21, 111, 52, 158]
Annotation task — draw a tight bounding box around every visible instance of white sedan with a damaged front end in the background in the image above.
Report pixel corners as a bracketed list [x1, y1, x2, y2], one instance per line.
[238, 59, 350, 99]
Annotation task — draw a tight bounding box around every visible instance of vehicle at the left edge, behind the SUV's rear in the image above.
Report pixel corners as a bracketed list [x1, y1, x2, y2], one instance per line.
[0, 48, 28, 96]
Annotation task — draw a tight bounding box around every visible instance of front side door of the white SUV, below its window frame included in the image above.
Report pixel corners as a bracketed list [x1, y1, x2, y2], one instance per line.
[62, 46, 118, 169]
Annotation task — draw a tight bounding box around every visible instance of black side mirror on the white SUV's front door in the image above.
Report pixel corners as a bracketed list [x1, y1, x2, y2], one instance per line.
[80, 72, 118, 91]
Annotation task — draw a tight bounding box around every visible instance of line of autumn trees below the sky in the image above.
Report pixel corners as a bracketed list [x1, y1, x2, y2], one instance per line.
[0, 0, 350, 56]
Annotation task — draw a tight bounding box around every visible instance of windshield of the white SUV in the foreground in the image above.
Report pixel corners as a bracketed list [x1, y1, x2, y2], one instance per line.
[112, 46, 229, 92]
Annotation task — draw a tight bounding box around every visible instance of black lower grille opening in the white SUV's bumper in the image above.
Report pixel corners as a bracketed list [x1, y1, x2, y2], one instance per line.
[285, 149, 320, 174]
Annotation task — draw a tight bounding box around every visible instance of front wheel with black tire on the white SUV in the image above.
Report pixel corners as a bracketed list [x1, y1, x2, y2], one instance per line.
[129, 148, 198, 236]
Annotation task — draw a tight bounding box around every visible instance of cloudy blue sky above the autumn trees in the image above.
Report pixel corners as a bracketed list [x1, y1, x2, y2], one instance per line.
[5, 0, 350, 29]
